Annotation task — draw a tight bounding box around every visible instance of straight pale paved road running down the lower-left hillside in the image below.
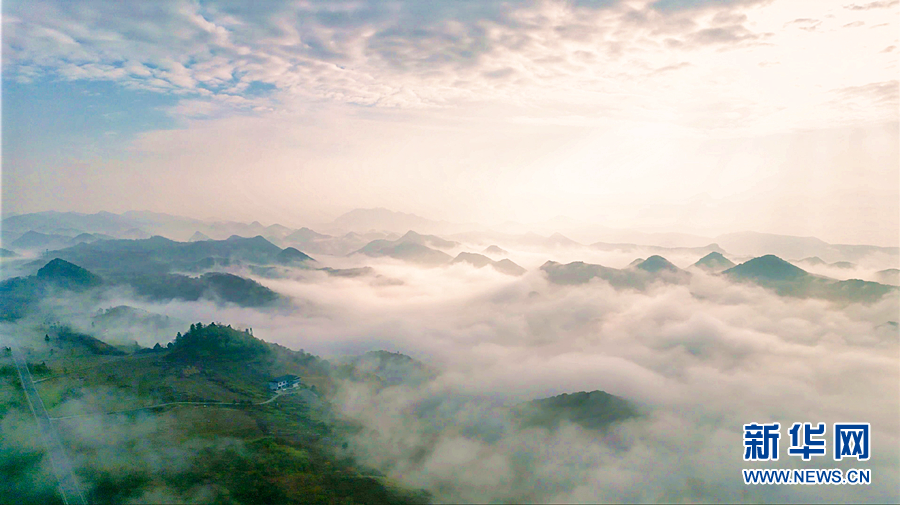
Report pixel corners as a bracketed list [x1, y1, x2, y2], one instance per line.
[12, 346, 87, 505]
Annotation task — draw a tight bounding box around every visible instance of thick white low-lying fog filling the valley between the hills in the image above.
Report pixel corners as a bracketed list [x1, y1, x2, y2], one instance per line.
[8, 244, 900, 502]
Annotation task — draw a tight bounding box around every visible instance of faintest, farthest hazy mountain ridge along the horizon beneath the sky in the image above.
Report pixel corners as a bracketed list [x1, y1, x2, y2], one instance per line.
[0, 208, 900, 268]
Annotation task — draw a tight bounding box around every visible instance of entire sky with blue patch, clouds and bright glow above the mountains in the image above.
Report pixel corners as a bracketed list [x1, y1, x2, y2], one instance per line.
[2, 0, 900, 246]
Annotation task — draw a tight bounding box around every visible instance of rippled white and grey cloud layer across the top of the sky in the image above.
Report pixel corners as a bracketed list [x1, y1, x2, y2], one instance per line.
[3, 0, 897, 130]
